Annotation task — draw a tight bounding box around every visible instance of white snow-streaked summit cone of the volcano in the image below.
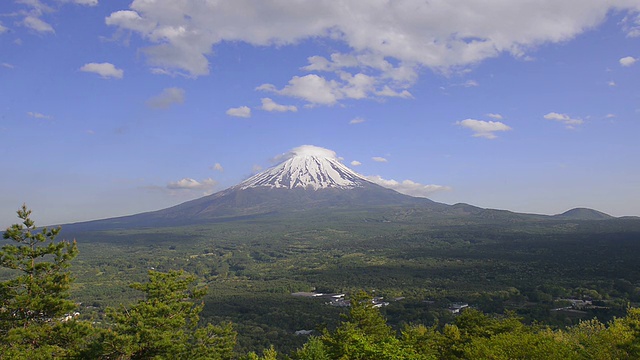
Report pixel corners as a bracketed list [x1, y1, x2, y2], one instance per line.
[236, 145, 369, 190]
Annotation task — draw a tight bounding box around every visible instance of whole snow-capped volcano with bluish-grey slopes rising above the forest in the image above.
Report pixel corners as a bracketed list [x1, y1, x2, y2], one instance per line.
[65, 145, 612, 231]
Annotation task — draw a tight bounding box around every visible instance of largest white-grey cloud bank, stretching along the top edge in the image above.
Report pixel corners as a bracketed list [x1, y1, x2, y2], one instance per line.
[107, 0, 638, 78]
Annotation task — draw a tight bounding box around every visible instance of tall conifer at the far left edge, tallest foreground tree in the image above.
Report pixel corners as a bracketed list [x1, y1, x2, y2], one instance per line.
[0, 205, 91, 359]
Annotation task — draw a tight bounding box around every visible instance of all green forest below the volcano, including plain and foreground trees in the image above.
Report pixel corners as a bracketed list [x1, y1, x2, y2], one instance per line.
[0, 207, 640, 359]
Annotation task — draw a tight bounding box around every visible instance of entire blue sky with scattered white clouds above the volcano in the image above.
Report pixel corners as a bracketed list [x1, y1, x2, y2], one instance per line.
[0, 0, 640, 226]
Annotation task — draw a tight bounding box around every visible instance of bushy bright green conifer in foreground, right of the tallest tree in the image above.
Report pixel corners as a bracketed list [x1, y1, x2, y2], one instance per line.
[103, 271, 235, 359]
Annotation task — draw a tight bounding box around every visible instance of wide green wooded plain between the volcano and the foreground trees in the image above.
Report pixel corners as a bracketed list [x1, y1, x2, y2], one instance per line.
[63, 208, 640, 352]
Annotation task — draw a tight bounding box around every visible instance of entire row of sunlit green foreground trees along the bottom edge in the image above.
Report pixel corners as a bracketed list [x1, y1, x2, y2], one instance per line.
[0, 206, 640, 360]
